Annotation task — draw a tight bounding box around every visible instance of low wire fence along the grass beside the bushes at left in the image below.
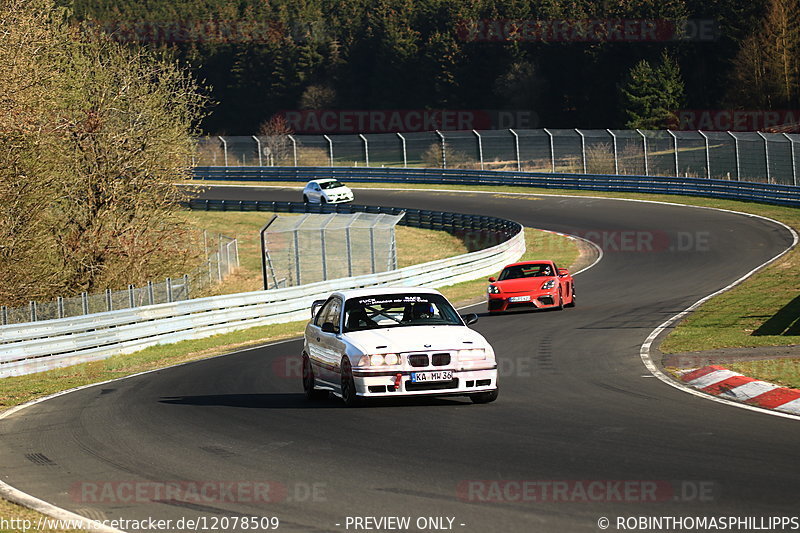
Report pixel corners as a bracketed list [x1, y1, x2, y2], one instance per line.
[0, 232, 239, 326]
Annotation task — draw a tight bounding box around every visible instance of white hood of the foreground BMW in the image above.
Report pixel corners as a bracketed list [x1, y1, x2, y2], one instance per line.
[345, 326, 489, 354]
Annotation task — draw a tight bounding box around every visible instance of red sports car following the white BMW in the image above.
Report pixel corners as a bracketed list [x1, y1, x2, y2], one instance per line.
[487, 261, 575, 312]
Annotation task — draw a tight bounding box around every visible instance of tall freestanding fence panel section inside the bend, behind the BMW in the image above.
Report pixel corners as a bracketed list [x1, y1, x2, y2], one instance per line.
[261, 213, 403, 289]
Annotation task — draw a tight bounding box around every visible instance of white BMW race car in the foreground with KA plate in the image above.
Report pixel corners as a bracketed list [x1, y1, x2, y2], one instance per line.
[302, 287, 497, 406]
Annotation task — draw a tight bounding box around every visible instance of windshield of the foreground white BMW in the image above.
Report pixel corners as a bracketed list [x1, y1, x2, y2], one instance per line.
[344, 293, 464, 331]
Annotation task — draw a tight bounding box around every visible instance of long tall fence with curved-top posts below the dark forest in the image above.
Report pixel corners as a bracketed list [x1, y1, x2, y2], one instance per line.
[194, 129, 800, 185]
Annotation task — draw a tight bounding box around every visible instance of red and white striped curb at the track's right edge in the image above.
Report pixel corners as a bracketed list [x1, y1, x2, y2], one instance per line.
[680, 365, 800, 415]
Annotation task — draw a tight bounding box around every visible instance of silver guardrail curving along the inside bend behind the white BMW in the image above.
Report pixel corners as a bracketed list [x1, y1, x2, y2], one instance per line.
[0, 202, 525, 378]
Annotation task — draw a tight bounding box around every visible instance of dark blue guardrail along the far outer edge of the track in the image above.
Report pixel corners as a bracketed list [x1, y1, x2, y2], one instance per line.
[194, 167, 800, 207]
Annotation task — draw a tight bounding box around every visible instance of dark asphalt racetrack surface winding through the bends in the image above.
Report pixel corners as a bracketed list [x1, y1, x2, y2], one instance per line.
[0, 188, 800, 532]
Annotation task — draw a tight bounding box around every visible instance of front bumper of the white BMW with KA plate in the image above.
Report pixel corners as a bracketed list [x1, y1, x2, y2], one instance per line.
[353, 365, 497, 398]
